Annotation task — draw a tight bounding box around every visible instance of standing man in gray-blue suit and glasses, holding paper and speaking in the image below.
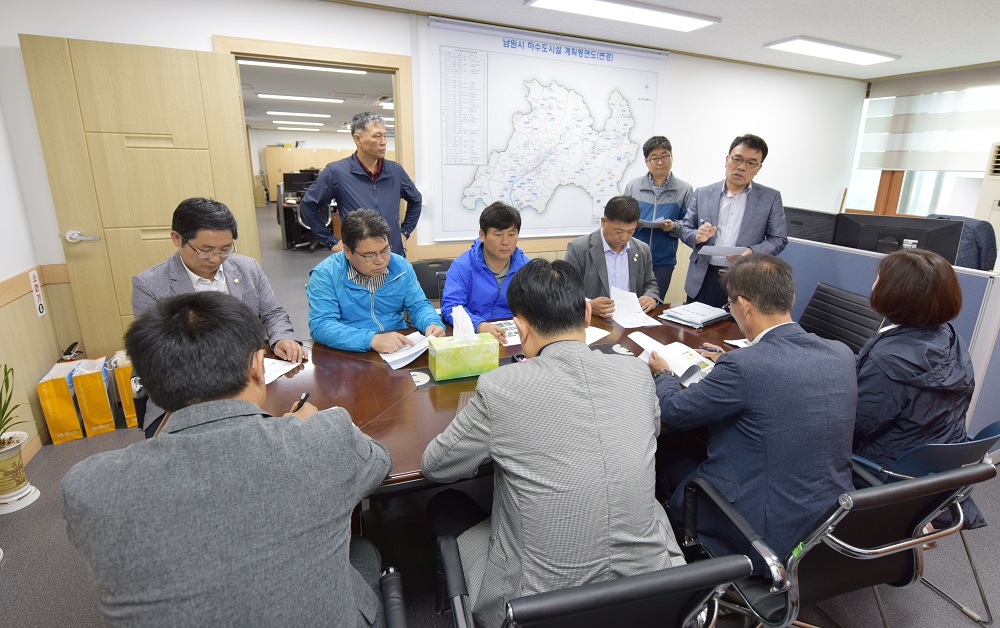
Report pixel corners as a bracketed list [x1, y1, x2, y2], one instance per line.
[681, 135, 788, 307]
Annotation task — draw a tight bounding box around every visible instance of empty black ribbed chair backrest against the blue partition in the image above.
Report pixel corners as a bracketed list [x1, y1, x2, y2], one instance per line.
[798, 283, 882, 353]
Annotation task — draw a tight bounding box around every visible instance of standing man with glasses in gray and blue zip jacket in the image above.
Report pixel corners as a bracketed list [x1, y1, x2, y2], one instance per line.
[625, 135, 692, 301]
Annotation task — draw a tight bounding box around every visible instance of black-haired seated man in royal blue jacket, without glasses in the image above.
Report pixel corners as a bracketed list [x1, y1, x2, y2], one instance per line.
[441, 201, 528, 344]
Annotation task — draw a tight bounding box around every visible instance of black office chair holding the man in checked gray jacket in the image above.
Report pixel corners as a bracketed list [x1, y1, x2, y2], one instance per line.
[438, 536, 750, 628]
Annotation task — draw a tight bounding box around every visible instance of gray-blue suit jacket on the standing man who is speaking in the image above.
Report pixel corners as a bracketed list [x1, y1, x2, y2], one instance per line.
[681, 180, 788, 298]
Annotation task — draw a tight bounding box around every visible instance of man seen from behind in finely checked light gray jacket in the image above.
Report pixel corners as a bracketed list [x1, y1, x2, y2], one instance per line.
[421, 259, 684, 627]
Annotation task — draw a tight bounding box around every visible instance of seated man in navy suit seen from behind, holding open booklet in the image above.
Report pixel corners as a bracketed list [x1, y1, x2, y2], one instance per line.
[649, 255, 858, 570]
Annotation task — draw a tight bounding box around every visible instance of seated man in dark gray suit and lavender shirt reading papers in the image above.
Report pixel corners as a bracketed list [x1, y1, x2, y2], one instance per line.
[566, 196, 660, 318]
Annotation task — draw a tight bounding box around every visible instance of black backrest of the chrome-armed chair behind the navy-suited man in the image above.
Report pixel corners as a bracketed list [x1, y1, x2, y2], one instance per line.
[787, 464, 997, 609]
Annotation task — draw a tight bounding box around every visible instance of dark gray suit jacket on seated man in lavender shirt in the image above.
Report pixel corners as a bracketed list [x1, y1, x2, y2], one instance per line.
[566, 229, 660, 301]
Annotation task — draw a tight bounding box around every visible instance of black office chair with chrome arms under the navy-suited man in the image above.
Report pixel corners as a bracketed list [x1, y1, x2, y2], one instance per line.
[684, 463, 997, 627]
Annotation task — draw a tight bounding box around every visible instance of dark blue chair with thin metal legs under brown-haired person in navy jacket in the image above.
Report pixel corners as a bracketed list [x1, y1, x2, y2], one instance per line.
[853, 421, 1000, 626]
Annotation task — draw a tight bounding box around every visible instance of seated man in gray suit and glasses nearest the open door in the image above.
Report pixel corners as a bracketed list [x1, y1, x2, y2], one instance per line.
[132, 198, 306, 438]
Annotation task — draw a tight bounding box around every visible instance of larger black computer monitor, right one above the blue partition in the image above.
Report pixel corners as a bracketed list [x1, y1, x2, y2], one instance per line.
[833, 214, 963, 264]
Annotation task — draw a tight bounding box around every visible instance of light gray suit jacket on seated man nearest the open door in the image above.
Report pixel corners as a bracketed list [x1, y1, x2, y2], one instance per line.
[132, 253, 302, 427]
